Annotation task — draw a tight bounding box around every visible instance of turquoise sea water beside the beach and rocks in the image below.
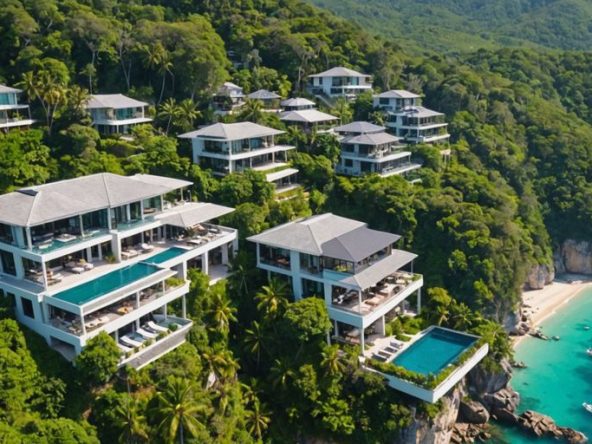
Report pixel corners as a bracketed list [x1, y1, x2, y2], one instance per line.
[492, 289, 592, 444]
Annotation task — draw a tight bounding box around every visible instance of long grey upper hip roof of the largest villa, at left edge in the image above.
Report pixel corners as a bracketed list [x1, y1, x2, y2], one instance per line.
[0, 173, 191, 226]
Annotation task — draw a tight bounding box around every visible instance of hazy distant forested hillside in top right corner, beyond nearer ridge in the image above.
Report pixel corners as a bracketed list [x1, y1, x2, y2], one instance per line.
[309, 0, 592, 51]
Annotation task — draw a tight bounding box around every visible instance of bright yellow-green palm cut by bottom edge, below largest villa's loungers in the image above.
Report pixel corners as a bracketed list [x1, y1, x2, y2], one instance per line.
[156, 377, 206, 444]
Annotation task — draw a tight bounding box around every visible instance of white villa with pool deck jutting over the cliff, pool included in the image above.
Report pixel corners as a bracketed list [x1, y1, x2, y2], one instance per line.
[248, 213, 488, 402]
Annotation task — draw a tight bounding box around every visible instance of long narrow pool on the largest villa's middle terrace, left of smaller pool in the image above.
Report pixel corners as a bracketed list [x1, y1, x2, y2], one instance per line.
[53, 263, 160, 305]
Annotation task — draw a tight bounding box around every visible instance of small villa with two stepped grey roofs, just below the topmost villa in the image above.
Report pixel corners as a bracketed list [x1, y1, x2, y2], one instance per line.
[280, 97, 339, 134]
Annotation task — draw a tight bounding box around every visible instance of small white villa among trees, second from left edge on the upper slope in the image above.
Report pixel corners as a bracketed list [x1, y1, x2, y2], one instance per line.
[86, 94, 152, 135]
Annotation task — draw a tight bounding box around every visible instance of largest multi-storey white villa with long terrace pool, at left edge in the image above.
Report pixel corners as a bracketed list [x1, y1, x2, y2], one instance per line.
[0, 173, 238, 368]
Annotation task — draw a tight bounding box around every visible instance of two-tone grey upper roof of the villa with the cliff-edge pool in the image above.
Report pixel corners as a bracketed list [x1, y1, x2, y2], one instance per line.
[248, 213, 400, 262]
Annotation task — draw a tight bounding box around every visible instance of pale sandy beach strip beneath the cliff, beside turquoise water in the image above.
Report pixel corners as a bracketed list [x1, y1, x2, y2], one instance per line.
[513, 275, 592, 348]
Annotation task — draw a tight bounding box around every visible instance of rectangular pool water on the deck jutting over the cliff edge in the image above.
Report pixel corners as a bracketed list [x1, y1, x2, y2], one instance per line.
[393, 328, 476, 375]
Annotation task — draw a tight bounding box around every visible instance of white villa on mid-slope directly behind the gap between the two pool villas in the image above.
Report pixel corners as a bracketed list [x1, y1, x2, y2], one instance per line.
[179, 122, 300, 194]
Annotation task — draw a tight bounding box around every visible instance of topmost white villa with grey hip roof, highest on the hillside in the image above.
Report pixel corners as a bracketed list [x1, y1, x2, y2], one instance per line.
[307, 66, 372, 99]
